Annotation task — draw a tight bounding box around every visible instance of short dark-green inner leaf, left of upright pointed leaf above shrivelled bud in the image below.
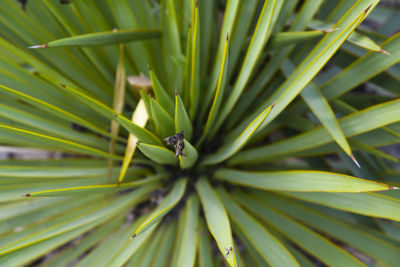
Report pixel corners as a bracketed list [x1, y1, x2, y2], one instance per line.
[150, 98, 175, 138]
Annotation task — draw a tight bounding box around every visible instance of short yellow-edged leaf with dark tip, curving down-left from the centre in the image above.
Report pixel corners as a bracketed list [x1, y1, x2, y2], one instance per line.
[132, 179, 187, 238]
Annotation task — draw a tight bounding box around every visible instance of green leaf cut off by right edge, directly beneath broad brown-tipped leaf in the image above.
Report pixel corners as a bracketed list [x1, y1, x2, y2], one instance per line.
[282, 192, 400, 221]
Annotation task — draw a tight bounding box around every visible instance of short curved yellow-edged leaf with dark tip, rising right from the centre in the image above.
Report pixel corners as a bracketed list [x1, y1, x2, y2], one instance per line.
[201, 104, 274, 165]
